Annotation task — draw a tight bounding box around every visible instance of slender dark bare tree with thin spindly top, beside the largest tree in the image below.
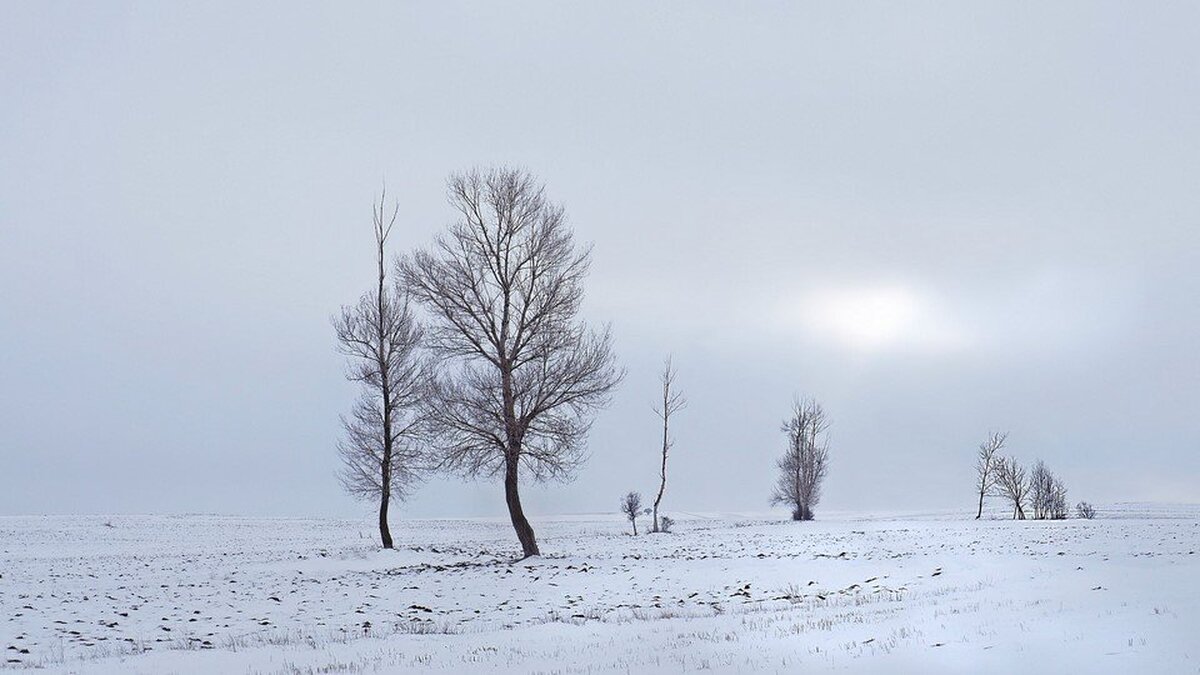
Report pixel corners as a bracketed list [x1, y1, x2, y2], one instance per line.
[332, 195, 426, 549]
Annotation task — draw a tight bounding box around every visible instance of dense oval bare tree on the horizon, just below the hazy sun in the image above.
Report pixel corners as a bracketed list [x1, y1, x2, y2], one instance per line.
[770, 399, 829, 520]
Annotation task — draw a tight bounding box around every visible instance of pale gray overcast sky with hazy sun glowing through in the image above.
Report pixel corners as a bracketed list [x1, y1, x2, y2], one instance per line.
[0, 2, 1200, 516]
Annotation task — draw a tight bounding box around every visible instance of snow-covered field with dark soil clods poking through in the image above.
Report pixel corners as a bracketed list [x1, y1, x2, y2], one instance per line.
[0, 504, 1200, 673]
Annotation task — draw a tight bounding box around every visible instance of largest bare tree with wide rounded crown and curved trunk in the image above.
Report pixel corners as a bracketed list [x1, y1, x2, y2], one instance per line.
[400, 168, 623, 557]
